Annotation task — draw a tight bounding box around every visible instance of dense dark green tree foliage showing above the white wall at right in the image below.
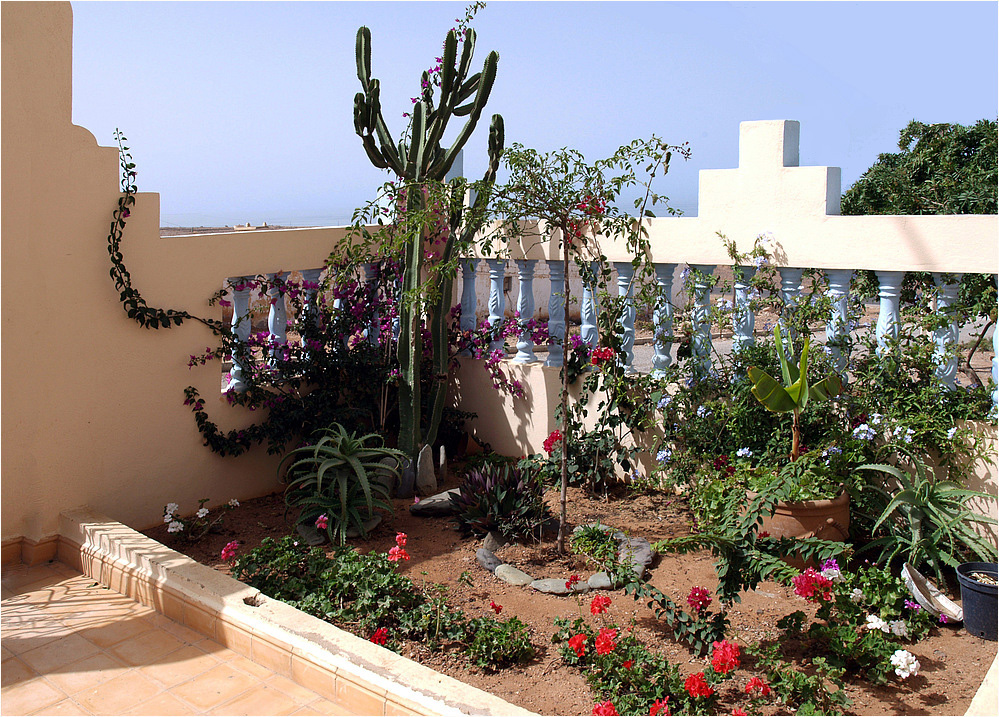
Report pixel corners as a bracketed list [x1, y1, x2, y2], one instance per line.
[841, 119, 997, 215]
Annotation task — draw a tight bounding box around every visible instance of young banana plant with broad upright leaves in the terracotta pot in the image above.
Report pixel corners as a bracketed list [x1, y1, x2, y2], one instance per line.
[749, 326, 843, 461]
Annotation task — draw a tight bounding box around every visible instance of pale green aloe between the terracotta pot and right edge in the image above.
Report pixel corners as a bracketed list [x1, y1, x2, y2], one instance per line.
[859, 446, 996, 582]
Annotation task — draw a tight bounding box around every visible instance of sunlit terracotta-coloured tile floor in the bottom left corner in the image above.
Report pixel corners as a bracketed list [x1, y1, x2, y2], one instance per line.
[0, 562, 360, 715]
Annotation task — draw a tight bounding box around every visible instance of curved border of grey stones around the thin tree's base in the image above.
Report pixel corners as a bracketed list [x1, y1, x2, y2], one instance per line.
[475, 521, 656, 595]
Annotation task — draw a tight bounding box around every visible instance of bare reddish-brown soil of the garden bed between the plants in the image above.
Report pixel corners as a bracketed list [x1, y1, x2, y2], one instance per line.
[146, 474, 996, 715]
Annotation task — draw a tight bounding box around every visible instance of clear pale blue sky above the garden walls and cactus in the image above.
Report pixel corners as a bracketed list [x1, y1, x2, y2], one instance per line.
[66, 0, 999, 226]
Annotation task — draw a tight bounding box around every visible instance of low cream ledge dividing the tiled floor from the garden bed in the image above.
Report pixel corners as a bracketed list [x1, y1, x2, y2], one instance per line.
[58, 507, 534, 715]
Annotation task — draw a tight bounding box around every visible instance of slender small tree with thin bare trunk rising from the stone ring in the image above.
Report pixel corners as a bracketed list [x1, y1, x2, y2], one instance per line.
[492, 137, 689, 553]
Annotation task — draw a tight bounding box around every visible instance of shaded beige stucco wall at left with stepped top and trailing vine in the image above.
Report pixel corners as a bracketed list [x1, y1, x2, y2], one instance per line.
[2, 2, 342, 540]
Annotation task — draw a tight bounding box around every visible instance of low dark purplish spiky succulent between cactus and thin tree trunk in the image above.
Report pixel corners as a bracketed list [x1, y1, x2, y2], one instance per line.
[451, 466, 548, 538]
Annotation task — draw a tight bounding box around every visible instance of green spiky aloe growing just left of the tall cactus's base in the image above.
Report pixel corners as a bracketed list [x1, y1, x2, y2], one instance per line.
[278, 423, 404, 545]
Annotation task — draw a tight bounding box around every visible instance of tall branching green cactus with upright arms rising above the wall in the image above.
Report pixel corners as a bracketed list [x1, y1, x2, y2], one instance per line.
[354, 27, 503, 457]
